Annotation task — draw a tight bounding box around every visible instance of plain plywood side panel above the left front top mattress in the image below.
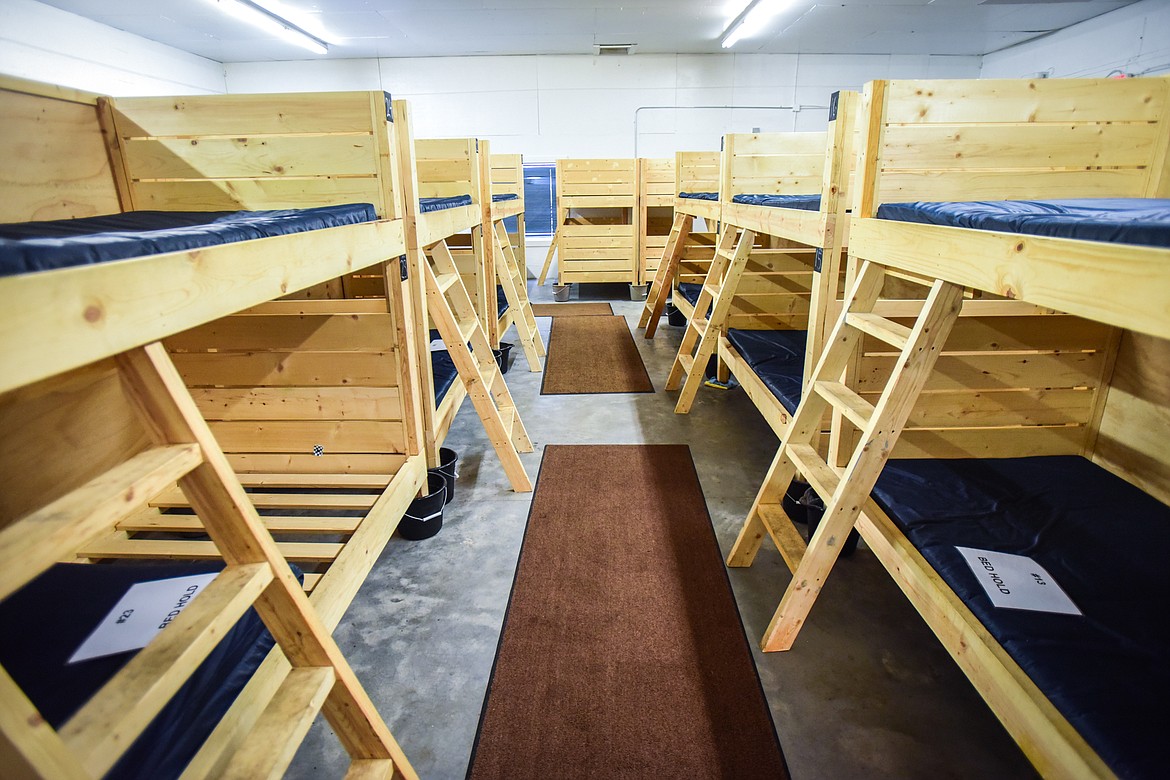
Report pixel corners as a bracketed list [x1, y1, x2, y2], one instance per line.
[0, 76, 122, 222]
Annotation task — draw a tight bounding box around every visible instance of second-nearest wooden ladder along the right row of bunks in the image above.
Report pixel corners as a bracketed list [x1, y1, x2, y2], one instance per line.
[666, 226, 756, 414]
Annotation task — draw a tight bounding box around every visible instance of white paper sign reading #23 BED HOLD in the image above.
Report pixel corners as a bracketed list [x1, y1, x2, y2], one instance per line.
[69, 572, 215, 663]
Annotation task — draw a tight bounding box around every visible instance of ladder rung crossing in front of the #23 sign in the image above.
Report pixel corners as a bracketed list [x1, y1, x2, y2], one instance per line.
[61, 564, 273, 776]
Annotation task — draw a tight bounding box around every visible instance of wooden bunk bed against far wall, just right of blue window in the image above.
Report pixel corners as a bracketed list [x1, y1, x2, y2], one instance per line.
[537, 158, 638, 287]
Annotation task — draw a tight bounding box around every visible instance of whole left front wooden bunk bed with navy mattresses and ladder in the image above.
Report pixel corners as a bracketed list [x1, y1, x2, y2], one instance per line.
[0, 78, 425, 778]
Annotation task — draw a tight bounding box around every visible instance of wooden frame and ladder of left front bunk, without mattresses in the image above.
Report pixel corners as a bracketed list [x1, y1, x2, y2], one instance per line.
[0, 78, 425, 776]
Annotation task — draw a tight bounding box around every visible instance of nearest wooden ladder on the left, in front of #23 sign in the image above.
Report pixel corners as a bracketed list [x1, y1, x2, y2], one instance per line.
[0, 343, 417, 778]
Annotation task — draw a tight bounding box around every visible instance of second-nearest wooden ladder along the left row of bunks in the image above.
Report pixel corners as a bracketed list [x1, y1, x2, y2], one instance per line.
[422, 241, 532, 492]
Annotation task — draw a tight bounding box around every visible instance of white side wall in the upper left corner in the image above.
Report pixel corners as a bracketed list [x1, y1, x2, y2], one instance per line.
[0, 0, 227, 96]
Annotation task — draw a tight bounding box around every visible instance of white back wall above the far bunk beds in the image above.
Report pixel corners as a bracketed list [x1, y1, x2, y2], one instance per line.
[225, 54, 979, 160]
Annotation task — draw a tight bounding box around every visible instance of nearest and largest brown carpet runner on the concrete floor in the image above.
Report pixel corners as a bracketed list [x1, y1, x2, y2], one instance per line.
[468, 444, 787, 780]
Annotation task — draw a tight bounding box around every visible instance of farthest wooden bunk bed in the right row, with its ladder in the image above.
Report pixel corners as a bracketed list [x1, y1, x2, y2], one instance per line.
[638, 152, 720, 339]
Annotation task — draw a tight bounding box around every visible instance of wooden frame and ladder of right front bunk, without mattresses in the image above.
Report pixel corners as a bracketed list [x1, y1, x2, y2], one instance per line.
[729, 78, 1170, 776]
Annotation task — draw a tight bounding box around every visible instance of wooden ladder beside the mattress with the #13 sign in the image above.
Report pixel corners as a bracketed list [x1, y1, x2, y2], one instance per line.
[728, 261, 963, 651]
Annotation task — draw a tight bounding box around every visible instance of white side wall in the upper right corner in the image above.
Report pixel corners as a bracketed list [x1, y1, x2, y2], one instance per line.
[979, 0, 1170, 78]
